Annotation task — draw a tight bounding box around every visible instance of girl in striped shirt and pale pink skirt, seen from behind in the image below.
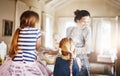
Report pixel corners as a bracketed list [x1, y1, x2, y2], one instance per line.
[0, 11, 49, 76]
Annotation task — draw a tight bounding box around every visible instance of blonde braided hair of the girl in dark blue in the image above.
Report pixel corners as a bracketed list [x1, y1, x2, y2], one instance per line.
[59, 38, 75, 76]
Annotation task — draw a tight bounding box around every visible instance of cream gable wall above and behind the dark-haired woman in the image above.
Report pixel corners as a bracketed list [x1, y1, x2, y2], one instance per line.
[55, 0, 120, 40]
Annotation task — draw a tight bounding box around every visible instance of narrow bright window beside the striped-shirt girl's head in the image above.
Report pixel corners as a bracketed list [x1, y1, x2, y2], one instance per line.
[43, 13, 53, 48]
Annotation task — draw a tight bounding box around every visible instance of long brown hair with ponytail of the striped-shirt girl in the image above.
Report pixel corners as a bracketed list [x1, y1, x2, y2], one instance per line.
[8, 10, 39, 58]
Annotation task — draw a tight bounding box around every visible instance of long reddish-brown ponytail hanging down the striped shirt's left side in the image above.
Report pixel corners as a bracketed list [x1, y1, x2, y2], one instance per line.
[8, 28, 20, 59]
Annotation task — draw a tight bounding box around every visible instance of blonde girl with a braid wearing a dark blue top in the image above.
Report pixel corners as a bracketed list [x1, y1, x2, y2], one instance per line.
[53, 38, 80, 76]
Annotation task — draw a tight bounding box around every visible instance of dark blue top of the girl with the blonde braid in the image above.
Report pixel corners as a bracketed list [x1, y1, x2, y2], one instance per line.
[53, 57, 80, 76]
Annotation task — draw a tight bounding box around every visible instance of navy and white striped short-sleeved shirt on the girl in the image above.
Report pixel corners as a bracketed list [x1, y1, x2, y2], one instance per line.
[13, 27, 41, 62]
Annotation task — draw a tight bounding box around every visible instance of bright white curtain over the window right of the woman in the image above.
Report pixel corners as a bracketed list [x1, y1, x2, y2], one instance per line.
[92, 17, 118, 56]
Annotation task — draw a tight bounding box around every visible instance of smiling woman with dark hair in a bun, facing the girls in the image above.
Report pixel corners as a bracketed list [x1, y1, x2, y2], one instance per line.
[67, 10, 91, 76]
